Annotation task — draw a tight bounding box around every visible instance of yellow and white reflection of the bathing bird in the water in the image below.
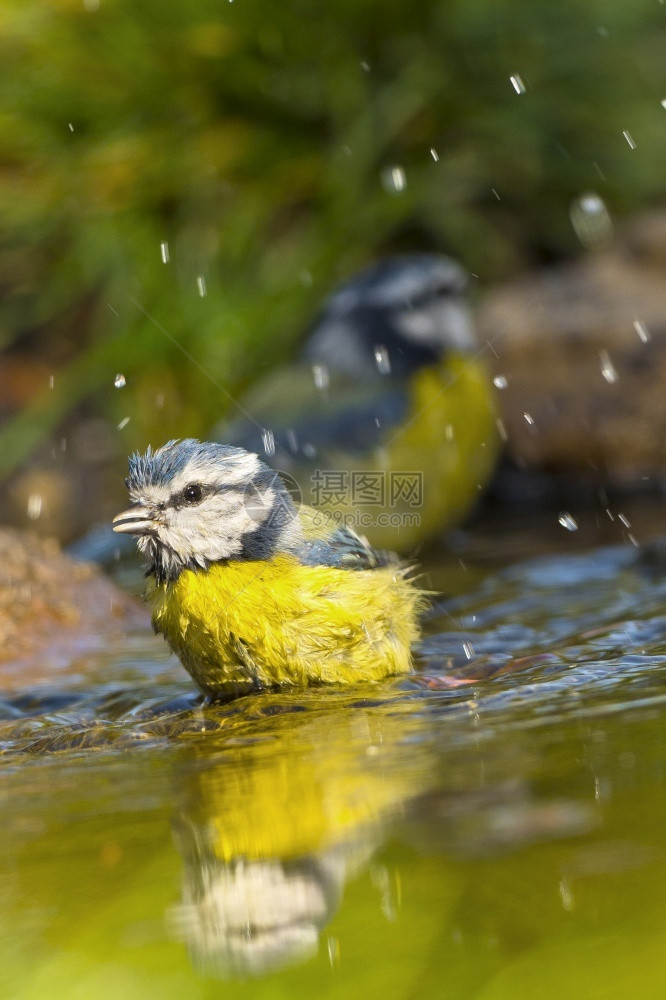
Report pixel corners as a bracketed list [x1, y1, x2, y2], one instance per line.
[170, 694, 432, 977]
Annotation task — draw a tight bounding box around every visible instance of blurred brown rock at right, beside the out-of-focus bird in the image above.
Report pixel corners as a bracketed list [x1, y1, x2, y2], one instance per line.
[479, 212, 666, 486]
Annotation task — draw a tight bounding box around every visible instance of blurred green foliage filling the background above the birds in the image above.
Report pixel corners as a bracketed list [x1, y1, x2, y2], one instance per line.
[0, 0, 666, 473]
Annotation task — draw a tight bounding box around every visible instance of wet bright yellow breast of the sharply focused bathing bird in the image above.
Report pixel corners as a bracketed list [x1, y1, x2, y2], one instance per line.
[148, 555, 423, 695]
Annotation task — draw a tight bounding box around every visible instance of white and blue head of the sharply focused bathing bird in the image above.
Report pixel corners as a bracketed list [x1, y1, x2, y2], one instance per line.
[113, 438, 300, 579]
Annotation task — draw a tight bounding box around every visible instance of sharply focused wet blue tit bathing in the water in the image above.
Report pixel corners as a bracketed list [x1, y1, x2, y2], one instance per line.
[113, 439, 424, 698]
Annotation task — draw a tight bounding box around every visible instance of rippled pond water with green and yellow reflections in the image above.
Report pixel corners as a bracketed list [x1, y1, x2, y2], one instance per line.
[0, 504, 666, 1000]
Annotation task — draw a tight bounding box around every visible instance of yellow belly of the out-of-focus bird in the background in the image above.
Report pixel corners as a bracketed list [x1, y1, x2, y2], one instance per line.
[294, 354, 500, 553]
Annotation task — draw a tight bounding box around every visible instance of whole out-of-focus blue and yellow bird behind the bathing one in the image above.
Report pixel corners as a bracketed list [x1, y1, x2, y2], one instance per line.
[215, 254, 499, 553]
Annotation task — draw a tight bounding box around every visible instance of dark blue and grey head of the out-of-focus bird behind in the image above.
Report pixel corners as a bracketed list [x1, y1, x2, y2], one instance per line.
[303, 254, 476, 378]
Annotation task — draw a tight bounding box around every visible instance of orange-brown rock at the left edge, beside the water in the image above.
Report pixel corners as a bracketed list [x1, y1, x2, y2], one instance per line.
[0, 528, 148, 690]
